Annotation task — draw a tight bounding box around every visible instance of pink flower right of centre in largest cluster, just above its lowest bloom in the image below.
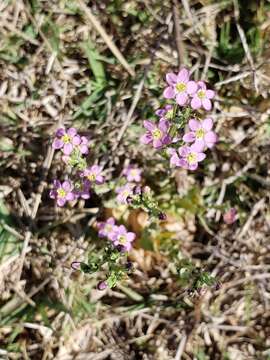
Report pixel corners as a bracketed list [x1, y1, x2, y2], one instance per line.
[183, 118, 218, 149]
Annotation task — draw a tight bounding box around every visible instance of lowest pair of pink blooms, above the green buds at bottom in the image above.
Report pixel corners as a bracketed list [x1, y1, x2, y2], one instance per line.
[97, 217, 136, 251]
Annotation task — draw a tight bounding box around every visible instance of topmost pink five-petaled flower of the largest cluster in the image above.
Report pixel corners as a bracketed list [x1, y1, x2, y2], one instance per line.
[163, 69, 198, 106]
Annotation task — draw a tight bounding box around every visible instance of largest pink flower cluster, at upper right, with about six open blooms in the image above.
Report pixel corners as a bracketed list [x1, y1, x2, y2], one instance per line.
[140, 69, 218, 170]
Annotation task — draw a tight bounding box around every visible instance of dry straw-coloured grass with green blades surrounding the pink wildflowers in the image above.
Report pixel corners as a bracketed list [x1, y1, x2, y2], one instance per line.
[0, 0, 270, 360]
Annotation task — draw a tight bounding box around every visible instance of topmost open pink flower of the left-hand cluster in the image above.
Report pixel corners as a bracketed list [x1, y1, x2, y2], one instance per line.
[52, 128, 81, 155]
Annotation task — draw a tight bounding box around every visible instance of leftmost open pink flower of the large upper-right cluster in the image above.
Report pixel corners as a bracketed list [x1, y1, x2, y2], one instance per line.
[140, 119, 171, 149]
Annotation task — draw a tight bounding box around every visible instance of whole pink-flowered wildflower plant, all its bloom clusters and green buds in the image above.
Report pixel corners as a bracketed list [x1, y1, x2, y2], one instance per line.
[49, 69, 217, 290]
